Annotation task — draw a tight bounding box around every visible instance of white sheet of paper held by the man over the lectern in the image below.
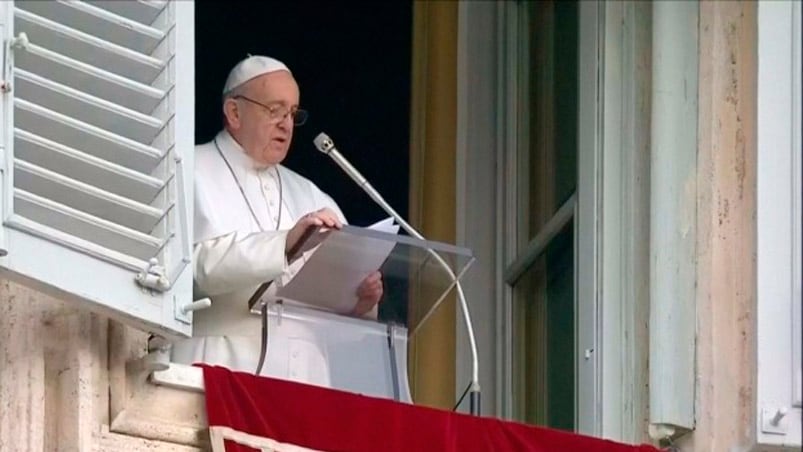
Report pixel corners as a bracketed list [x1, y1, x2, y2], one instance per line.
[276, 219, 399, 314]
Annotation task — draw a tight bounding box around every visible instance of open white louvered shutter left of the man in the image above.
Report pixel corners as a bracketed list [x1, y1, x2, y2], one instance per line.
[0, 0, 194, 335]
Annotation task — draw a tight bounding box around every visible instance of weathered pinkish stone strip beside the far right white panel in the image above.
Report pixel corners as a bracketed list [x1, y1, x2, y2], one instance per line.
[681, 1, 757, 451]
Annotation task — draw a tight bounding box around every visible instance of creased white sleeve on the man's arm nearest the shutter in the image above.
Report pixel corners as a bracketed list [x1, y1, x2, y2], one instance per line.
[192, 231, 288, 297]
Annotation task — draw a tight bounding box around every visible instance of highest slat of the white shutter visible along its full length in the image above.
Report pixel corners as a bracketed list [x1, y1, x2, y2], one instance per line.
[14, 9, 165, 84]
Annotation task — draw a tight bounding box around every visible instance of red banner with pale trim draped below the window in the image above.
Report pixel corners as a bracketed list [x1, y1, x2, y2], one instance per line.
[202, 366, 657, 452]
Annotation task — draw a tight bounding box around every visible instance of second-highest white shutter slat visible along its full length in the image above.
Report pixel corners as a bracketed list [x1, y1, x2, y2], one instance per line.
[14, 43, 166, 114]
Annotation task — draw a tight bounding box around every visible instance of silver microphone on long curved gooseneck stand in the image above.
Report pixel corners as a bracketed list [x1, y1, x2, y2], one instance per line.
[313, 133, 480, 416]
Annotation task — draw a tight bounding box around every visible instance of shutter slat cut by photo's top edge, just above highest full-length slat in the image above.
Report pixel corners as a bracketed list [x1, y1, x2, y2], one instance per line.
[16, 1, 165, 55]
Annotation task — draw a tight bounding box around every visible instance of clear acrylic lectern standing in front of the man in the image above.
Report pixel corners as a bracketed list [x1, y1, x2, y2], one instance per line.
[251, 225, 474, 402]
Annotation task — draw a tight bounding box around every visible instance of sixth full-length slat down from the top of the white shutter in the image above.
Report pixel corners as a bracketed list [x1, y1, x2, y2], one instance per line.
[14, 159, 164, 234]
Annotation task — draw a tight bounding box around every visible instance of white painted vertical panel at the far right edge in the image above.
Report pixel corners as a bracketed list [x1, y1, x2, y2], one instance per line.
[755, 2, 803, 447]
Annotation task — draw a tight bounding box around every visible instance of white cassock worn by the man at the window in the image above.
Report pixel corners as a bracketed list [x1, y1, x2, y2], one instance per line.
[171, 131, 345, 386]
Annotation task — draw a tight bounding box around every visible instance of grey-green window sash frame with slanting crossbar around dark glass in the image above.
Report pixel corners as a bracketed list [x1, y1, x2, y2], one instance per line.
[497, 2, 580, 433]
